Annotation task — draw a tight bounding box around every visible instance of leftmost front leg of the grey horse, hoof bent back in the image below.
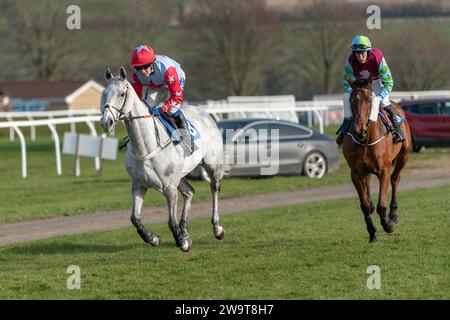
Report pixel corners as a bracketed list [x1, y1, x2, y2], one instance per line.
[131, 181, 161, 246]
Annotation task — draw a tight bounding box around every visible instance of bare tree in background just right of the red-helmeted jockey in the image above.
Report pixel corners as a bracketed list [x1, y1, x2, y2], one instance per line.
[186, 0, 277, 97]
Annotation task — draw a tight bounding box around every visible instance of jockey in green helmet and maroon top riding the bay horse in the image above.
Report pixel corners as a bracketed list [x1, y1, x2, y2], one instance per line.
[336, 35, 405, 144]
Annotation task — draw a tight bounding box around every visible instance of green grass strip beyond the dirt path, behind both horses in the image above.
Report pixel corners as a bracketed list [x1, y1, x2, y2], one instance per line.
[0, 126, 450, 223]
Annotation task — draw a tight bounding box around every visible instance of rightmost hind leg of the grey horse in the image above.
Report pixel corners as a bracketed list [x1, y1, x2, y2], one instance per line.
[202, 162, 225, 240]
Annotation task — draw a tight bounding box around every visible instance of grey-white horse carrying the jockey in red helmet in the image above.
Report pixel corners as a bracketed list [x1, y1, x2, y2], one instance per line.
[100, 67, 226, 252]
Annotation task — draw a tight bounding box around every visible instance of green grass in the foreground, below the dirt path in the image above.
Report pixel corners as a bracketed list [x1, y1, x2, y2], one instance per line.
[0, 186, 450, 299]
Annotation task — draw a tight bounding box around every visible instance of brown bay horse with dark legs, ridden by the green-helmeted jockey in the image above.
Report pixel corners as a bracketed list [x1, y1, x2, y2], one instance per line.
[343, 77, 411, 243]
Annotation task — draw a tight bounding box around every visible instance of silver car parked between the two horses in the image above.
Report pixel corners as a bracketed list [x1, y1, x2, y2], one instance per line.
[189, 118, 340, 179]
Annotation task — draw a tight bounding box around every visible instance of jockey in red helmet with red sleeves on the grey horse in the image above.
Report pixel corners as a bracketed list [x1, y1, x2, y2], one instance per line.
[130, 45, 194, 155]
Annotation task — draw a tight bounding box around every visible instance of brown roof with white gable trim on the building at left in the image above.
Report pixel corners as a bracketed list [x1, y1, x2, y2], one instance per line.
[0, 80, 103, 102]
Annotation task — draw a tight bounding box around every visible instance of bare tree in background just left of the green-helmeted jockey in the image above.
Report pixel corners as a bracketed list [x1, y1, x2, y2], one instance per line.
[289, 0, 365, 93]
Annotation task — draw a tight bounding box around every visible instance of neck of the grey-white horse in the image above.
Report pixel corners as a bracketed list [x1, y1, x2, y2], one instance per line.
[124, 89, 161, 156]
